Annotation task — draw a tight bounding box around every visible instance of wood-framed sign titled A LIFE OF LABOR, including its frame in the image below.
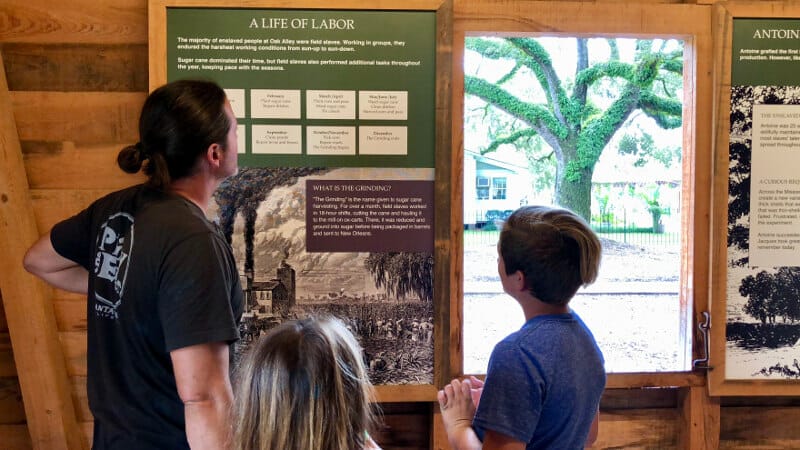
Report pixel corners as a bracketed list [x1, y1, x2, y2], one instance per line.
[149, 0, 449, 401]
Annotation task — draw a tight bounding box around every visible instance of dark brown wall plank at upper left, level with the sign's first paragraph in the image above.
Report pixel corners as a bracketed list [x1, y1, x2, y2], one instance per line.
[3, 43, 147, 92]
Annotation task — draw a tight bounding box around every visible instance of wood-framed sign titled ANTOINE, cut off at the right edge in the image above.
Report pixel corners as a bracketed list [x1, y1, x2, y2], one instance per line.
[709, 7, 800, 395]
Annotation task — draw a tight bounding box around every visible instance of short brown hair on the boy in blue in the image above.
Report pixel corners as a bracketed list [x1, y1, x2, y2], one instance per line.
[497, 206, 602, 305]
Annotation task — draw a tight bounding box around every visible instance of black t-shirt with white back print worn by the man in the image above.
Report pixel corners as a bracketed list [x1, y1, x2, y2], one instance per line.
[51, 186, 243, 450]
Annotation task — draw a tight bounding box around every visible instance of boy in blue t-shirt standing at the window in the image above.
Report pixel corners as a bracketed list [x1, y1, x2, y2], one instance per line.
[438, 206, 606, 450]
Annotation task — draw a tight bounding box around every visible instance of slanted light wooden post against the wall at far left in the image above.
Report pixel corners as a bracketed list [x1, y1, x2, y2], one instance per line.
[0, 54, 87, 450]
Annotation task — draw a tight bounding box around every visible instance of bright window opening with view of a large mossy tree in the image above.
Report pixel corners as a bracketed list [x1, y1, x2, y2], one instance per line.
[462, 37, 691, 373]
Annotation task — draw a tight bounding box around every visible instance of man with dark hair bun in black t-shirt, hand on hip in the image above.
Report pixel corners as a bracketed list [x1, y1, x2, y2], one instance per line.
[23, 80, 242, 450]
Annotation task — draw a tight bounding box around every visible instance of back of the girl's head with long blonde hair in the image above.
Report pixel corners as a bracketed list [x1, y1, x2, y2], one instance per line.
[233, 317, 375, 450]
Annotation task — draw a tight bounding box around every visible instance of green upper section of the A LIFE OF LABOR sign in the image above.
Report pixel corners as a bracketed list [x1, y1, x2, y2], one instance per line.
[167, 8, 436, 168]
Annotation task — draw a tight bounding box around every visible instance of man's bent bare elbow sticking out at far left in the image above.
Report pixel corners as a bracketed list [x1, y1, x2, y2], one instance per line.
[22, 233, 89, 294]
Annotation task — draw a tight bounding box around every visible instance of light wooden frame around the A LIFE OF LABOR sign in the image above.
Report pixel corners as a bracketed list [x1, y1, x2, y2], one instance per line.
[148, 0, 453, 402]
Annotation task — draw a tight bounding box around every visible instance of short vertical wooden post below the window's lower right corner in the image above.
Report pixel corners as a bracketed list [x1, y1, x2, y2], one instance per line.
[678, 386, 720, 450]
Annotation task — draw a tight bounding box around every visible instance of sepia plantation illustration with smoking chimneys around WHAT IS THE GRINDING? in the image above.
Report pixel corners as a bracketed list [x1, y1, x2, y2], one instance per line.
[215, 168, 434, 385]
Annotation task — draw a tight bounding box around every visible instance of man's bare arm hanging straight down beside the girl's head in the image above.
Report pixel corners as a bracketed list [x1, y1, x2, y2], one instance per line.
[170, 342, 233, 450]
